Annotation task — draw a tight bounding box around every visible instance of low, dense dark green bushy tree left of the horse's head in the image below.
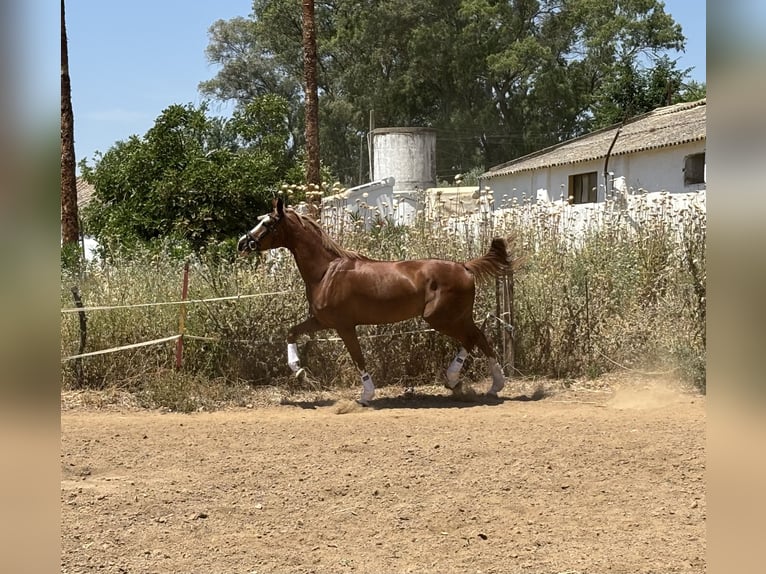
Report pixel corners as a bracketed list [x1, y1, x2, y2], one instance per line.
[81, 95, 295, 255]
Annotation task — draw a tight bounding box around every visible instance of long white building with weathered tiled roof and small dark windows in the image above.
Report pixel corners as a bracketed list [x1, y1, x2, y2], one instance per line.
[479, 99, 706, 207]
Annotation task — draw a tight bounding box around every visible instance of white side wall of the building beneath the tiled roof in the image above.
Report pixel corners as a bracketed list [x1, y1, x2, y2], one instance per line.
[480, 141, 706, 207]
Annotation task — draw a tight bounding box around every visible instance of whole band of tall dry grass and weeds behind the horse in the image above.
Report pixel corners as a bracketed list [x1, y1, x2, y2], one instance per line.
[61, 186, 706, 410]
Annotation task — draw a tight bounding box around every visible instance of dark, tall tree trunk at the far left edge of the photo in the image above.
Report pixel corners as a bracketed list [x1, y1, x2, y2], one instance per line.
[61, 0, 80, 245]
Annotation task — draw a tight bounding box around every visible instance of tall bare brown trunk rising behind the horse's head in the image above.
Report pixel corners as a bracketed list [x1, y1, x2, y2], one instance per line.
[302, 0, 321, 215]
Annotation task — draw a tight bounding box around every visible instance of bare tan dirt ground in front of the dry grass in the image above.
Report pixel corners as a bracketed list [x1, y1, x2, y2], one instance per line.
[61, 377, 706, 574]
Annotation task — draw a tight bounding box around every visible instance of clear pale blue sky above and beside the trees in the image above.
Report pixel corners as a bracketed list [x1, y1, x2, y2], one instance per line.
[58, 0, 706, 173]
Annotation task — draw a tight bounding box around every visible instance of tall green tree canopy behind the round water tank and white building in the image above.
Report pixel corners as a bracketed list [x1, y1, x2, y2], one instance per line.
[200, 0, 704, 183]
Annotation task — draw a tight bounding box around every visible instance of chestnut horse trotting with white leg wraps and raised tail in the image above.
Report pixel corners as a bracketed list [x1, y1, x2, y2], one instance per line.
[237, 197, 514, 406]
